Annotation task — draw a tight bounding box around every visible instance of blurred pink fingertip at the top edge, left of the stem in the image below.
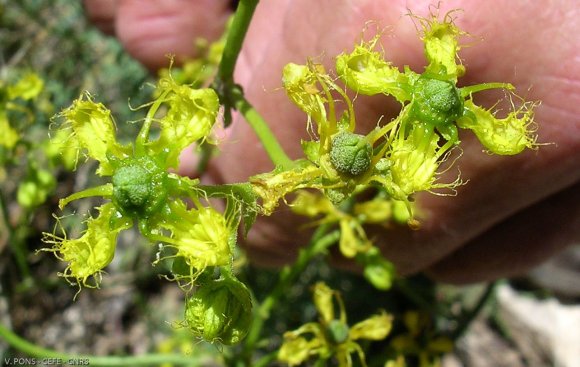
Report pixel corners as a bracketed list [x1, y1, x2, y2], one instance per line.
[115, 0, 231, 70]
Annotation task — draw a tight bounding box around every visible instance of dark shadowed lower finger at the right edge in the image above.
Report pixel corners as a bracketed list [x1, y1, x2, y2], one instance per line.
[428, 184, 580, 283]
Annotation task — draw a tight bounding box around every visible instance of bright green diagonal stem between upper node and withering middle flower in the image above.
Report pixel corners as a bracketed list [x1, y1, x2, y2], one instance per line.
[233, 92, 294, 169]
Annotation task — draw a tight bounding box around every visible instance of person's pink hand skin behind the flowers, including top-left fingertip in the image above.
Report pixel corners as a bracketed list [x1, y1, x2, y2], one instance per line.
[85, 0, 580, 283]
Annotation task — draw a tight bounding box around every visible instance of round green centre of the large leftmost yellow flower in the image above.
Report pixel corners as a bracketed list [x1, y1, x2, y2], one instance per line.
[112, 157, 167, 217]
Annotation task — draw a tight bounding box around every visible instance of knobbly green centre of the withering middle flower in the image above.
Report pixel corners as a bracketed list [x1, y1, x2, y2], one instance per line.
[330, 131, 373, 176]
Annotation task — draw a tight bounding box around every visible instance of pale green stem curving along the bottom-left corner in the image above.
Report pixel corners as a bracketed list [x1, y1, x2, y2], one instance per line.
[0, 324, 203, 367]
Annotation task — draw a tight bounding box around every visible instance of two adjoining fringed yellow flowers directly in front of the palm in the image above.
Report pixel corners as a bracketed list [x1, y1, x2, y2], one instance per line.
[251, 14, 535, 257]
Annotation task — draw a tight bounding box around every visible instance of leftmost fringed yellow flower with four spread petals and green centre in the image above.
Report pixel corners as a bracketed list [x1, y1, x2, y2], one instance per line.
[45, 78, 224, 292]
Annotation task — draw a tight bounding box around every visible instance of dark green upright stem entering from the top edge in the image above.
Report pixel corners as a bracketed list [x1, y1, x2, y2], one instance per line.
[218, 0, 259, 83]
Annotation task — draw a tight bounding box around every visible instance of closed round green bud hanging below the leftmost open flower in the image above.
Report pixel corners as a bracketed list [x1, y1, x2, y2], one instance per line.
[185, 278, 252, 345]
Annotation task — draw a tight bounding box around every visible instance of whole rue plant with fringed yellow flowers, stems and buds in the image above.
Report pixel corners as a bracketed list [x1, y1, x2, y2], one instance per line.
[0, 0, 536, 366]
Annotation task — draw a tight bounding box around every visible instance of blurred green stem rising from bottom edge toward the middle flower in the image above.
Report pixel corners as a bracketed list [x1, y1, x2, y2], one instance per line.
[242, 224, 340, 365]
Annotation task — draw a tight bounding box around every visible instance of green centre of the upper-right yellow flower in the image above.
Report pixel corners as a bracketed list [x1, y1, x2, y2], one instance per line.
[411, 76, 463, 126]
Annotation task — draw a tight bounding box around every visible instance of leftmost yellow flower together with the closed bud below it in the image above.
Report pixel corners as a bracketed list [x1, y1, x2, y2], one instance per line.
[44, 77, 251, 344]
